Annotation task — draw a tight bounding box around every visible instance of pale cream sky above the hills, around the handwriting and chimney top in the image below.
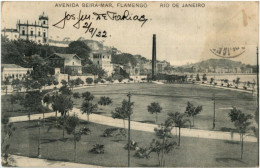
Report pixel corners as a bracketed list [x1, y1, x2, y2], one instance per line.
[1, 1, 259, 65]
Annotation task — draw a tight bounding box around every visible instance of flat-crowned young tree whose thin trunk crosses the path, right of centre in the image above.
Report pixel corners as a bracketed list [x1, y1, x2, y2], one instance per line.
[165, 112, 190, 146]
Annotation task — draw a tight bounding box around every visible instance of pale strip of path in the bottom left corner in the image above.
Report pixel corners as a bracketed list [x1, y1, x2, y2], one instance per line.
[9, 155, 102, 167]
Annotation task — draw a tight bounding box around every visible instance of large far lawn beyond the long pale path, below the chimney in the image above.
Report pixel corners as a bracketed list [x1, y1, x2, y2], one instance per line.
[71, 83, 257, 130]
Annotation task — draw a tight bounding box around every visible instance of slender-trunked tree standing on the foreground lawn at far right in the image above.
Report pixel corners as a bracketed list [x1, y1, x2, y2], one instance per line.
[229, 107, 253, 160]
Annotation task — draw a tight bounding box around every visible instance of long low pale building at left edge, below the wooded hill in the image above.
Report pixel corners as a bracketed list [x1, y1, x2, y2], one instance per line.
[1, 64, 33, 81]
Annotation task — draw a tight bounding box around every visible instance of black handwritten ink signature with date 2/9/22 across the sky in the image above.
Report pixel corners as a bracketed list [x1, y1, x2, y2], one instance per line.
[53, 10, 148, 38]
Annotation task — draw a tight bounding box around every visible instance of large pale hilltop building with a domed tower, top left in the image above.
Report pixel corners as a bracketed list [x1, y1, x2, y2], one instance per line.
[2, 12, 49, 44]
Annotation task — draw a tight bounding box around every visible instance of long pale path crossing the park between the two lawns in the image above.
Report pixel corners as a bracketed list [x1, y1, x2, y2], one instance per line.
[9, 108, 257, 142]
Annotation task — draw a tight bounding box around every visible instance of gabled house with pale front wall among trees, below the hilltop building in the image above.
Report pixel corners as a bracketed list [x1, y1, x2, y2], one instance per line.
[47, 53, 82, 75]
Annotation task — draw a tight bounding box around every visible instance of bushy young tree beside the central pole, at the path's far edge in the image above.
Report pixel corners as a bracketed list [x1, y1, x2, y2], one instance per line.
[111, 99, 134, 128]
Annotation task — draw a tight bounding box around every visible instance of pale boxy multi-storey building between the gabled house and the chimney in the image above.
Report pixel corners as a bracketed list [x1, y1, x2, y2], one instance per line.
[92, 51, 114, 76]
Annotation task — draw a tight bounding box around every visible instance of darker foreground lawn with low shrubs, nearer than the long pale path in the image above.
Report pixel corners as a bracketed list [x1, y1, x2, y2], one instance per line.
[6, 121, 258, 167]
